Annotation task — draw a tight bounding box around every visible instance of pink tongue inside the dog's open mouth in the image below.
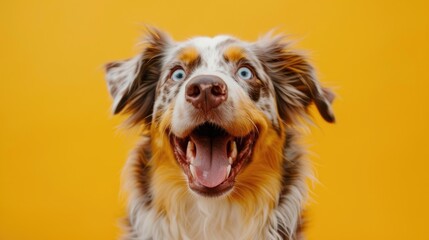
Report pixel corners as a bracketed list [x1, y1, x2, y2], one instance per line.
[191, 135, 229, 188]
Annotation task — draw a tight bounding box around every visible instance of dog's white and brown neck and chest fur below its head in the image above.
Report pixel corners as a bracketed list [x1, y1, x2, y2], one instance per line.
[124, 129, 307, 240]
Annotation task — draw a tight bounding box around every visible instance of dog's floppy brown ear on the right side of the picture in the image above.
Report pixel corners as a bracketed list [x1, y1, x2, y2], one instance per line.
[255, 35, 335, 123]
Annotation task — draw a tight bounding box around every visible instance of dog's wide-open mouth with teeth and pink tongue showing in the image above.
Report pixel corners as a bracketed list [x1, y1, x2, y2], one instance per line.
[170, 123, 257, 197]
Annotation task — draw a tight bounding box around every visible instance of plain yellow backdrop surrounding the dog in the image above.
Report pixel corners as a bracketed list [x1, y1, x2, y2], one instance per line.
[0, 0, 429, 240]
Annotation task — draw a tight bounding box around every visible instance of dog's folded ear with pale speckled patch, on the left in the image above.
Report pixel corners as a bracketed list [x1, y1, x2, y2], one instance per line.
[105, 28, 172, 125]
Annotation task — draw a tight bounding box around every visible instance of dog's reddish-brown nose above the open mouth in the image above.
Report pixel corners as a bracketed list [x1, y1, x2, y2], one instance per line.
[186, 75, 228, 112]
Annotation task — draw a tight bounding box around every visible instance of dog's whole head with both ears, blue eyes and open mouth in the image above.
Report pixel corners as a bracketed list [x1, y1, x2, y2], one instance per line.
[106, 30, 334, 199]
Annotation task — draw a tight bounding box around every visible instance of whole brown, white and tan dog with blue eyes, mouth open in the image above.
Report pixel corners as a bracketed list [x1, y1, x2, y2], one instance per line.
[105, 28, 335, 240]
